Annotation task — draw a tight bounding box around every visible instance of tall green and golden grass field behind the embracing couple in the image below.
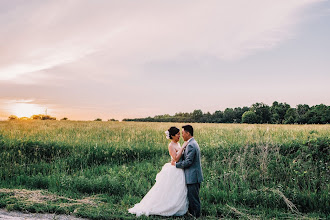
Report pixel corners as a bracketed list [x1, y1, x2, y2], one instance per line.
[0, 121, 330, 219]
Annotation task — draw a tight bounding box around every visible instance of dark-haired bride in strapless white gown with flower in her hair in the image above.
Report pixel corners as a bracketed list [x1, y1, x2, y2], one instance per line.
[128, 127, 188, 217]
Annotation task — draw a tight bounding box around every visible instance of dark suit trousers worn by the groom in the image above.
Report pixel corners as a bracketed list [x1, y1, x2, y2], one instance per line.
[187, 183, 201, 218]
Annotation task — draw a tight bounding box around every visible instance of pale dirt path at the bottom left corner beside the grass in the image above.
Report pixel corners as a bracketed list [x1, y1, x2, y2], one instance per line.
[0, 209, 86, 220]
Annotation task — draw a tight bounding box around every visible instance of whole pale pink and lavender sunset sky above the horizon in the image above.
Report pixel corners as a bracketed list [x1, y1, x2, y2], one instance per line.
[0, 0, 330, 120]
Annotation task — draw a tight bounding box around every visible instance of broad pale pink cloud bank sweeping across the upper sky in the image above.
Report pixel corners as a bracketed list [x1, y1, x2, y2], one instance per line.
[0, 0, 320, 80]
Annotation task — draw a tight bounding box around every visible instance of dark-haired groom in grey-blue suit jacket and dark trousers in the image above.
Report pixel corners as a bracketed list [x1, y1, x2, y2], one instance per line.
[172, 125, 203, 218]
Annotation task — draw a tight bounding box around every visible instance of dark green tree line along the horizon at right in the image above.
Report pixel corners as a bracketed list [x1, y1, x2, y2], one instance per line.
[123, 101, 330, 124]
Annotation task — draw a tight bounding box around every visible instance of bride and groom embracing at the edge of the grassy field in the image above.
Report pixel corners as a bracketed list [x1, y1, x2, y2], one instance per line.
[128, 125, 203, 218]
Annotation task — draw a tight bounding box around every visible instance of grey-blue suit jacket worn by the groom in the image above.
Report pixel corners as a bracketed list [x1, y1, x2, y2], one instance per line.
[175, 138, 203, 184]
